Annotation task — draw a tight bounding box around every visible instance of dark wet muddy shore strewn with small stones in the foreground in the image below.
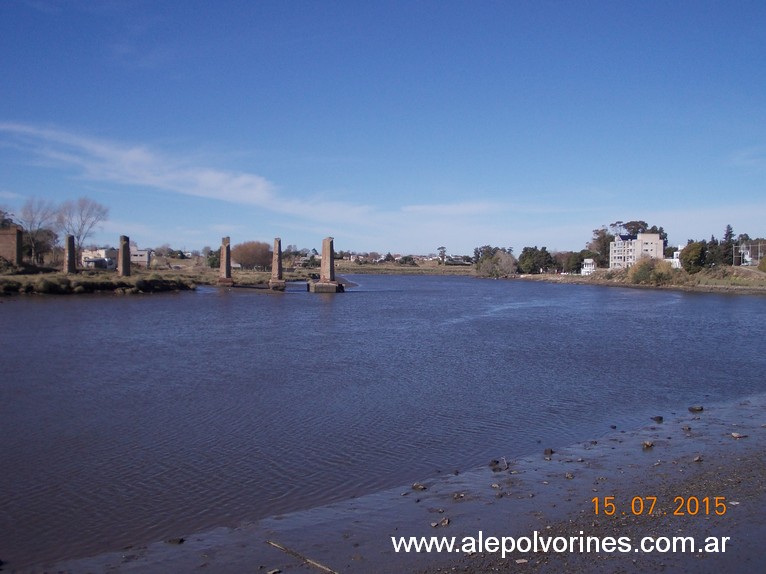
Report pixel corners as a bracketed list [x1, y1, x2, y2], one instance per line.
[27, 395, 766, 574]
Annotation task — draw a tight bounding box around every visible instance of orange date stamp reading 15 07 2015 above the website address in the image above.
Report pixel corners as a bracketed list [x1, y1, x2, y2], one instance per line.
[591, 496, 726, 516]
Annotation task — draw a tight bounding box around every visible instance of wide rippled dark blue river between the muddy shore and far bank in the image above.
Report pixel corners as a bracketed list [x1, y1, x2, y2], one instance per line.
[0, 276, 766, 567]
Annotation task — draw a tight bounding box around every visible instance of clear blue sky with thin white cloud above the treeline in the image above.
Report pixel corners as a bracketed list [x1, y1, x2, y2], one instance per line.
[0, 0, 766, 254]
